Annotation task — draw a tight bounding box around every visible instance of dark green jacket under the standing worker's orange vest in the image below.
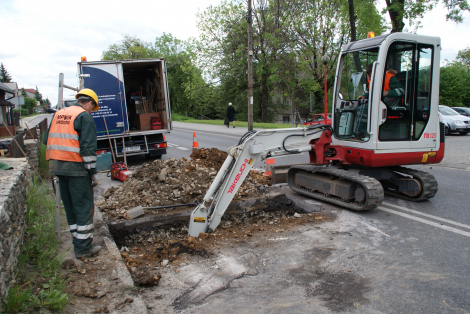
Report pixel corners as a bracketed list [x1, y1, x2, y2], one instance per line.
[42, 104, 97, 177]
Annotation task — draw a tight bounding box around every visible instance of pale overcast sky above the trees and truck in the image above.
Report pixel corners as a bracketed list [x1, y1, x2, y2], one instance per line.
[0, 0, 470, 106]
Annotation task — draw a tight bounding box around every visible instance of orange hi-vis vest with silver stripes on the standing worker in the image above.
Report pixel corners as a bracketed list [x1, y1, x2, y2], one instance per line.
[46, 106, 85, 162]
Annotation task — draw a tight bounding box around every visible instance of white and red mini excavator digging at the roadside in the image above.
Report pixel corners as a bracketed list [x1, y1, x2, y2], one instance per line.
[189, 33, 445, 237]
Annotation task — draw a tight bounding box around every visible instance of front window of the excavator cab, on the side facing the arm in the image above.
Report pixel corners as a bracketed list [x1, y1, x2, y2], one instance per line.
[334, 47, 379, 142]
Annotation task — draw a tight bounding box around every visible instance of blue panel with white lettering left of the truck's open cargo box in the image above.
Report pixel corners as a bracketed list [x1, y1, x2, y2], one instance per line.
[79, 61, 129, 137]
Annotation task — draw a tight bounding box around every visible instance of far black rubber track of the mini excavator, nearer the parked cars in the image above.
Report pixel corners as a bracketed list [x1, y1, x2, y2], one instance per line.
[385, 166, 437, 202]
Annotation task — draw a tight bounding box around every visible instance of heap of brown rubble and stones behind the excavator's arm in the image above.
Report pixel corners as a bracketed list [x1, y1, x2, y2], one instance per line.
[96, 148, 270, 220]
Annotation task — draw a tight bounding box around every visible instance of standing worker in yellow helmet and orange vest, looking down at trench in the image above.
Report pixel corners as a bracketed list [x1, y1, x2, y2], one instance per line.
[43, 88, 101, 258]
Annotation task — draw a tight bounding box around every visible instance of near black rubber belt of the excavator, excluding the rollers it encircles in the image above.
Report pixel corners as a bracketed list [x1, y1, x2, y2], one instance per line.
[287, 165, 384, 211]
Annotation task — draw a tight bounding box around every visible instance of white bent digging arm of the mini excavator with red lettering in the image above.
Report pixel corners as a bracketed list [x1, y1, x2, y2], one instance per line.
[189, 125, 331, 237]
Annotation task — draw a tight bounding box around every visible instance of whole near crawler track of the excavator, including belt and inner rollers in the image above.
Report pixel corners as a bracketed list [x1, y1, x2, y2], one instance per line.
[287, 165, 384, 211]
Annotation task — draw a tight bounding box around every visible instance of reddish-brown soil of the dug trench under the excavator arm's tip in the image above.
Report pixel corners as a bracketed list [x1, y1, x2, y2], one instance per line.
[116, 208, 333, 286]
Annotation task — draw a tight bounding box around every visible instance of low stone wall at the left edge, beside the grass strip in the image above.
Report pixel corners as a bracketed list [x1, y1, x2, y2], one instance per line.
[0, 158, 32, 298]
